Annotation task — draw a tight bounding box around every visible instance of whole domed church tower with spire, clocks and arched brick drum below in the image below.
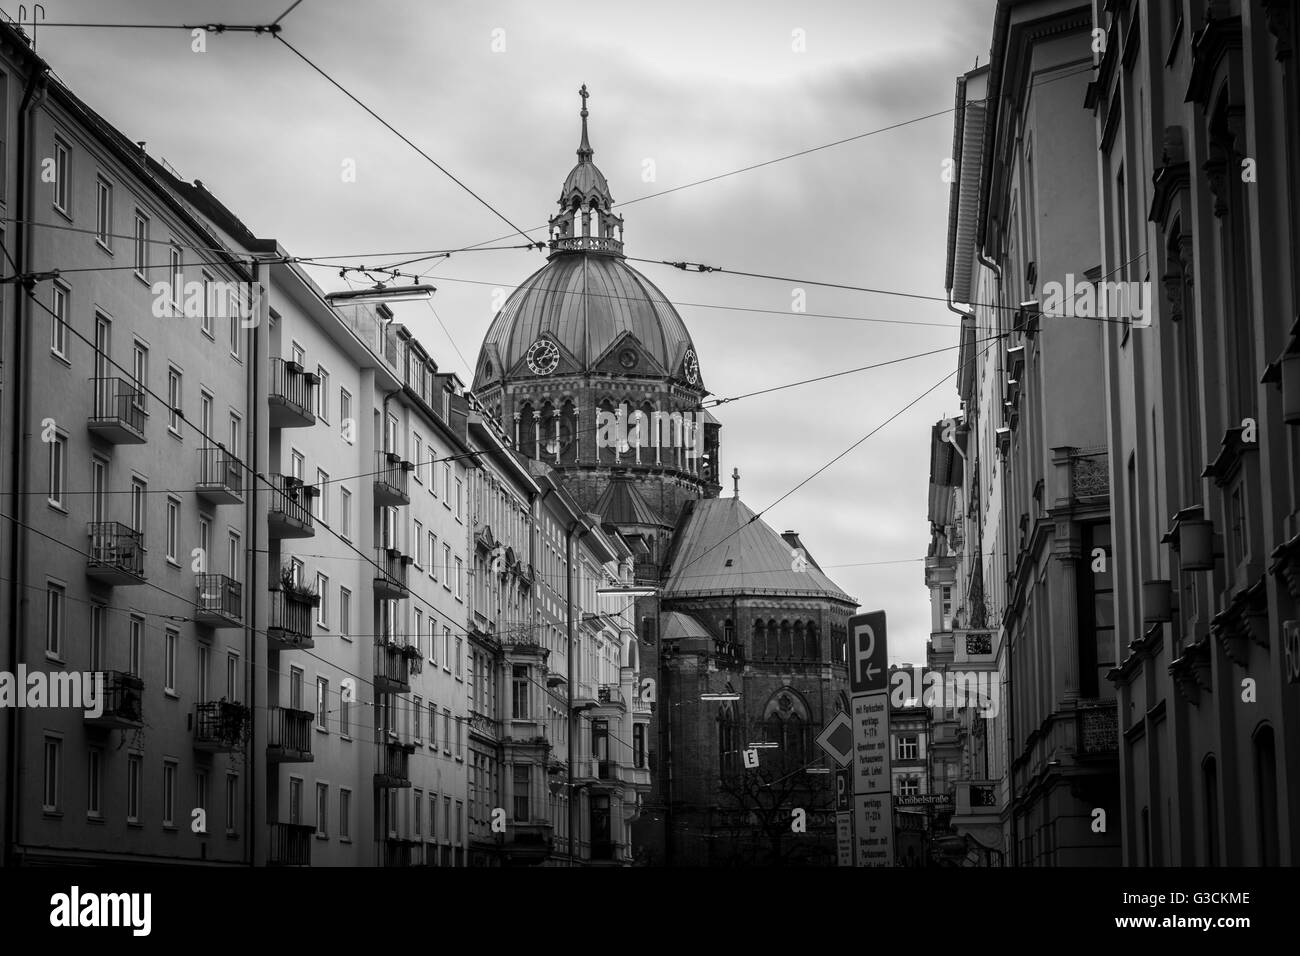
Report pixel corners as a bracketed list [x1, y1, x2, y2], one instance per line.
[473, 85, 720, 561]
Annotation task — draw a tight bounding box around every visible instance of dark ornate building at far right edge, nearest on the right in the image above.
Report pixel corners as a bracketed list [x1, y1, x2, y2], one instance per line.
[1086, 0, 1300, 866]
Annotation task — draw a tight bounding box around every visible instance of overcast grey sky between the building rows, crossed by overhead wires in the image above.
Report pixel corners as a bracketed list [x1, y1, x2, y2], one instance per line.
[32, 0, 995, 662]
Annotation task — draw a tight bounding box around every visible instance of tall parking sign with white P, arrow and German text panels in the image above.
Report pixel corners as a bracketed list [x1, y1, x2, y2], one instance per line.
[849, 611, 893, 866]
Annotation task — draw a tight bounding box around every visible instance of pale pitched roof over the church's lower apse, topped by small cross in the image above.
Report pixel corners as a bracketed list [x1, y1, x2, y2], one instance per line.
[663, 498, 858, 606]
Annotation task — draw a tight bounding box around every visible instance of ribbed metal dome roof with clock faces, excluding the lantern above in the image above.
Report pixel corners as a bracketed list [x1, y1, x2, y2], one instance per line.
[475, 251, 703, 389]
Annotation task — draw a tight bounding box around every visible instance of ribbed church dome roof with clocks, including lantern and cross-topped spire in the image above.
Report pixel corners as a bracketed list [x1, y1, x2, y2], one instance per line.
[473, 86, 703, 392]
